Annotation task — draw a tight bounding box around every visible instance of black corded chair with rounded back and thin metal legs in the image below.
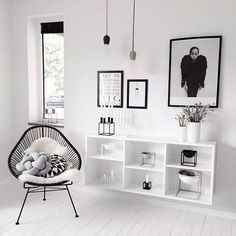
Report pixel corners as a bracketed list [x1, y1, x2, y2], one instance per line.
[8, 125, 82, 225]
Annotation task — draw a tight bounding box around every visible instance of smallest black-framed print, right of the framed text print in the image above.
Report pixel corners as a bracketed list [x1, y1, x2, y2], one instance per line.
[127, 79, 148, 109]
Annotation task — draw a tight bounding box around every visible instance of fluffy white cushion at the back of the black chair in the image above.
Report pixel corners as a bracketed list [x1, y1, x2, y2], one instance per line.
[24, 137, 67, 157]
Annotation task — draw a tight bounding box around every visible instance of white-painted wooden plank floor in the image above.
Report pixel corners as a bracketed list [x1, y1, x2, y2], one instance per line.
[0, 181, 236, 236]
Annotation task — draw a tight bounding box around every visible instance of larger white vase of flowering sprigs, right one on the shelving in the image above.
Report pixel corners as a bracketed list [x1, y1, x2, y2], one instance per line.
[183, 103, 212, 143]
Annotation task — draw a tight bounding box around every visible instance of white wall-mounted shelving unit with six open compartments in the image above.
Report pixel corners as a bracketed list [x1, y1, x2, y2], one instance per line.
[85, 135, 216, 205]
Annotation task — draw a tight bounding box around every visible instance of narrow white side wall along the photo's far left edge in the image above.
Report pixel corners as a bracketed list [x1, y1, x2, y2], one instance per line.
[0, 0, 12, 183]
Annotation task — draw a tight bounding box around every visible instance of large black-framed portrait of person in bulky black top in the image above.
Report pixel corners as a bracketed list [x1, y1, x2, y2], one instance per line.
[168, 36, 222, 107]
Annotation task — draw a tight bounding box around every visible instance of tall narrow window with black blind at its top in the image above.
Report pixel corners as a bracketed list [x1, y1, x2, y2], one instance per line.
[41, 22, 64, 120]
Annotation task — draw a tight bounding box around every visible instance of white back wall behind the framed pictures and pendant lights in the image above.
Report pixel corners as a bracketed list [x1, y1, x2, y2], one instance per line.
[12, 0, 236, 211]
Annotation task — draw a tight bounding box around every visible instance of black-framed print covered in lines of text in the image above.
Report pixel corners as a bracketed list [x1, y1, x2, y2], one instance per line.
[97, 71, 124, 107]
